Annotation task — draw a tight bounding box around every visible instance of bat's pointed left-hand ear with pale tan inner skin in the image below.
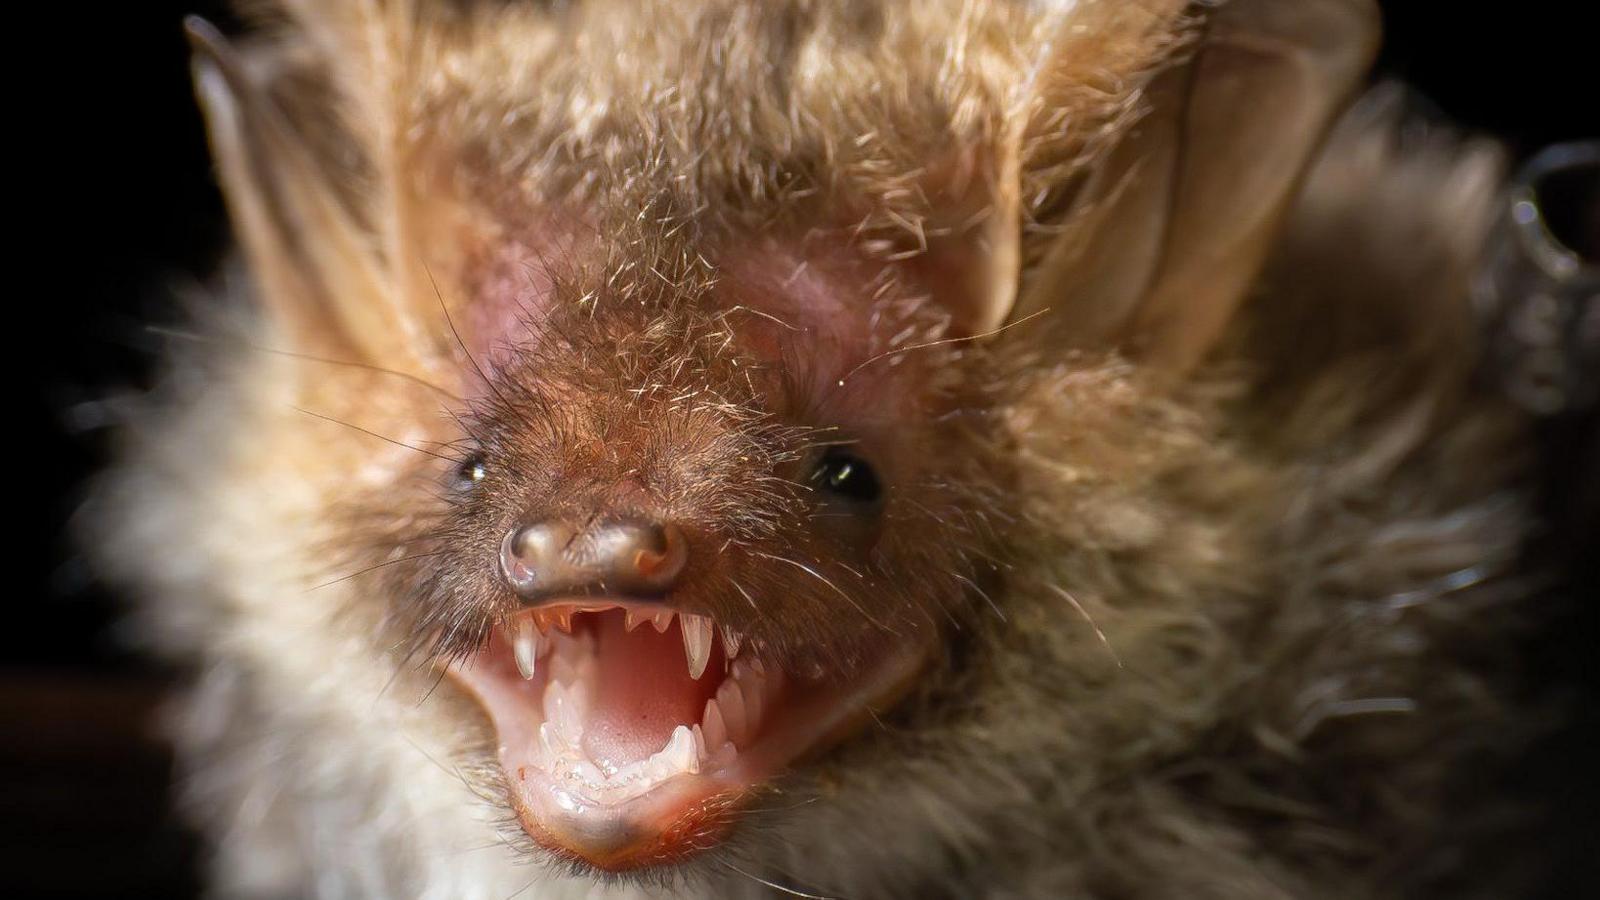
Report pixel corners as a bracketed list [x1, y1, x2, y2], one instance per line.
[186, 11, 437, 367]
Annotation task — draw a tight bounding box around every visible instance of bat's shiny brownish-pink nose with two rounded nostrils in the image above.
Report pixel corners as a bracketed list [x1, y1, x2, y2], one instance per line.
[501, 519, 688, 602]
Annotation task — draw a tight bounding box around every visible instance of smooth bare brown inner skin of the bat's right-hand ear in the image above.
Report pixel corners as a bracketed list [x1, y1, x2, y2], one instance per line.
[1013, 0, 1378, 372]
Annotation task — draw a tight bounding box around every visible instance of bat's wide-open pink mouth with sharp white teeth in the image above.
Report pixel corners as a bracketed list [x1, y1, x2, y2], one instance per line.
[448, 597, 926, 870]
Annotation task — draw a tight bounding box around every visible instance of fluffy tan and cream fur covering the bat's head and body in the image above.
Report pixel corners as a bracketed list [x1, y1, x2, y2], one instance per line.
[91, 0, 1548, 898]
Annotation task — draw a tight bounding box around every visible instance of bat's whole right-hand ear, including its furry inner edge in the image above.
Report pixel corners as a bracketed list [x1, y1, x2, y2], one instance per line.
[990, 0, 1379, 370]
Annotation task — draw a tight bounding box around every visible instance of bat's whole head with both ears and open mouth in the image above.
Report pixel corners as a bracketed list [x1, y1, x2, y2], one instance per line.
[147, 0, 1373, 874]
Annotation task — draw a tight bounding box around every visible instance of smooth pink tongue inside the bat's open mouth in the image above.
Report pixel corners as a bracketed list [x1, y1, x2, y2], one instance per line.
[582, 610, 722, 770]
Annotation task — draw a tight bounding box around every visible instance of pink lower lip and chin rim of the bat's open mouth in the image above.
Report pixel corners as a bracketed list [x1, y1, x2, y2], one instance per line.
[448, 605, 928, 871]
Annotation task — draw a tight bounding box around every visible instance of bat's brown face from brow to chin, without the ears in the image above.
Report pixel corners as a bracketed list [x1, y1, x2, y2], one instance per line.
[366, 224, 1000, 870]
